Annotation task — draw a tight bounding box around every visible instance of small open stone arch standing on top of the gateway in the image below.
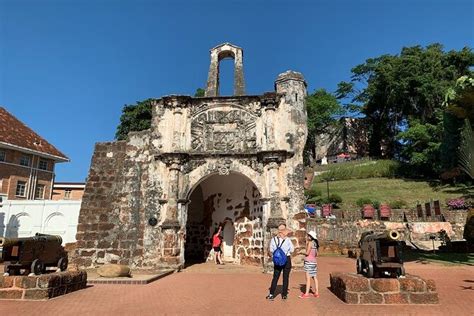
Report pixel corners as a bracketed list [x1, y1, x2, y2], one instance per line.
[205, 43, 245, 97]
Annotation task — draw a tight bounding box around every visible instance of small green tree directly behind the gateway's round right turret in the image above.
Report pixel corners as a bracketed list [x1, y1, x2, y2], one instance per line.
[305, 89, 344, 164]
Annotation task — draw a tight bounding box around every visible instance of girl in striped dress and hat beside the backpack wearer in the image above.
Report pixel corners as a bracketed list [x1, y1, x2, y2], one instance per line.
[299, 231, 319, 298]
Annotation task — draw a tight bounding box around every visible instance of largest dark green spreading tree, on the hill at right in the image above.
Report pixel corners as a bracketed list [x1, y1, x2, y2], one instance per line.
[336, 44, 474, 163]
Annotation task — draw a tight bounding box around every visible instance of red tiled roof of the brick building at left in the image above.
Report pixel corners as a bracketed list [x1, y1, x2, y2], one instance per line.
[0, 106, 69, 160]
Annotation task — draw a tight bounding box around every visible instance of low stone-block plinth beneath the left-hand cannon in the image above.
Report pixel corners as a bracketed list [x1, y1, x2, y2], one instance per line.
[0, 271, 87, 300]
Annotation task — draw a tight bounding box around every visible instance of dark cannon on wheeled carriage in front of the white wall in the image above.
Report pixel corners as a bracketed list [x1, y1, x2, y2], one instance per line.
[0, 233, 68, 275]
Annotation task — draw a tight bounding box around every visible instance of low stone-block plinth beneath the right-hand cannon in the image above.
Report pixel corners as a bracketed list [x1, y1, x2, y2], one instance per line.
[330, 272, 439, 304]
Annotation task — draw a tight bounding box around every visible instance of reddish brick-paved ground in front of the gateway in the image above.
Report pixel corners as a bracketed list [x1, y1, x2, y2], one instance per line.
[0, 257, 474, 316]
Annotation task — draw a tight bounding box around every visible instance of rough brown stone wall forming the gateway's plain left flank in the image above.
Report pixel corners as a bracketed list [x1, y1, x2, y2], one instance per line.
[74, 142, 151, 267]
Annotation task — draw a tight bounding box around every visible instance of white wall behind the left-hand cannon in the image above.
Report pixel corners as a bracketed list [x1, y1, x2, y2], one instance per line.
[0, 200, 81, 245]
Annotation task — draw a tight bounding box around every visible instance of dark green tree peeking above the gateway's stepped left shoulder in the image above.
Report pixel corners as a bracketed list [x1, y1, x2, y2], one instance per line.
[115, 99, 155, 140]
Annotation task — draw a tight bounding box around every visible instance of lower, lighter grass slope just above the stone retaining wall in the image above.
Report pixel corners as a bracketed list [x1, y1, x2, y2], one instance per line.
[313, 178, 461, 209]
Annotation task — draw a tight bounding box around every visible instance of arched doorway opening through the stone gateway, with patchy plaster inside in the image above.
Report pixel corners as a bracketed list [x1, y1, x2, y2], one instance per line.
[184, 172, 263, 266]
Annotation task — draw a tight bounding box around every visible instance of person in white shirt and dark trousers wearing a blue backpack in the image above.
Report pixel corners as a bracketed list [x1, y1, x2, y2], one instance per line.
[266, 224, 295, 301]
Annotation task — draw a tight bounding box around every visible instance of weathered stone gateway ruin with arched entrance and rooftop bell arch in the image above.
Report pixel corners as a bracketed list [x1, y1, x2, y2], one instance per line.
[75, 43, 307, 269]
